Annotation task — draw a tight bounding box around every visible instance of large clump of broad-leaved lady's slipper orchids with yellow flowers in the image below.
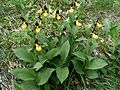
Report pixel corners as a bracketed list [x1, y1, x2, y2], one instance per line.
[8, 1, 120, 90]
